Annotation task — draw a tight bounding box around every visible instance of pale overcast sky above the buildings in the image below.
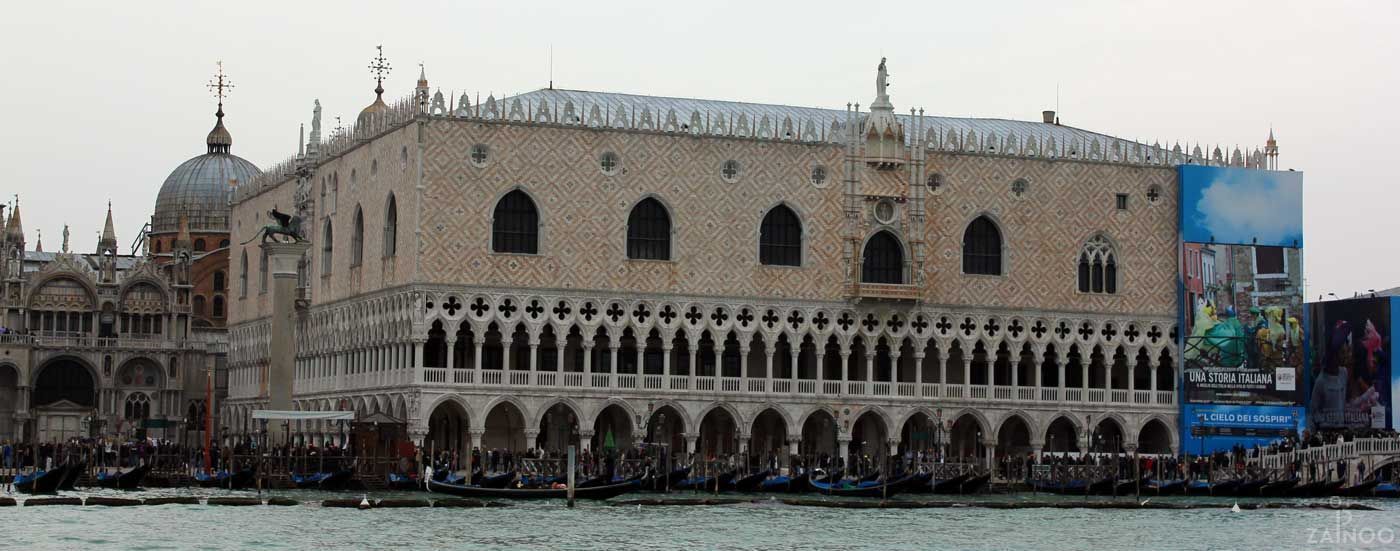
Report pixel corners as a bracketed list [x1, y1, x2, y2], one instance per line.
[0, 0, 1400, 299]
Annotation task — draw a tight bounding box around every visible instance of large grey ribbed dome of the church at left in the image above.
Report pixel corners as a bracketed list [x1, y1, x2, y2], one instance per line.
[151, 152, 260, 234]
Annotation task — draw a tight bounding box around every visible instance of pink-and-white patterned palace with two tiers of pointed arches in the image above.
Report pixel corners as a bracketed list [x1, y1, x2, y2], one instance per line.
[224, 56, 1260, 461]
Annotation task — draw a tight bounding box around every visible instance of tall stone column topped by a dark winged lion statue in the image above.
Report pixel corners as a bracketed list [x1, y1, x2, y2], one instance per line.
[262, 242, 311, 443]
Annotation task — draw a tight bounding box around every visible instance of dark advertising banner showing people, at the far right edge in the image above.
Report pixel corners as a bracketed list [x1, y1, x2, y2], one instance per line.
[1305, 296, 1400, 429]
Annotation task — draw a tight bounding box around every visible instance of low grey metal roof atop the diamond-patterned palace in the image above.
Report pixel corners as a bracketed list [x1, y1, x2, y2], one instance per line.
[501, 88, 1135, 153]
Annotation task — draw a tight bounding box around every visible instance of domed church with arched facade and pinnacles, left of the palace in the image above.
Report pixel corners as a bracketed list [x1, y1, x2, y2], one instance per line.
[0, 97, 259, 443]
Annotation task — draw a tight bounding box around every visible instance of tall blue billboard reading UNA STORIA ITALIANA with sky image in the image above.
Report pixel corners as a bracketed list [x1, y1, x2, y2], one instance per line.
[1179, 165, 1306, 452]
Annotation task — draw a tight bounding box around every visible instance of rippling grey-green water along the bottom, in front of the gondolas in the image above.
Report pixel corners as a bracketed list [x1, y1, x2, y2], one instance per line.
[0, 489, 1400, 550]
